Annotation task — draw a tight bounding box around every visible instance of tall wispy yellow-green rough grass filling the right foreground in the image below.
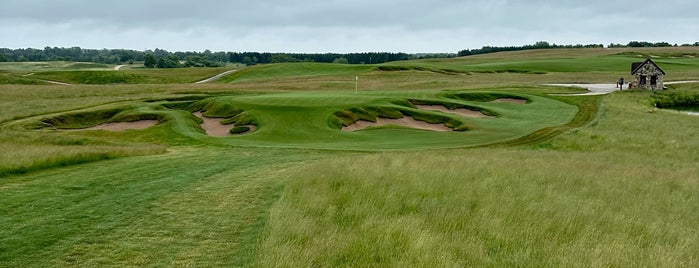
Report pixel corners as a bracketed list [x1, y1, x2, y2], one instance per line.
[257, 92, 699, 267]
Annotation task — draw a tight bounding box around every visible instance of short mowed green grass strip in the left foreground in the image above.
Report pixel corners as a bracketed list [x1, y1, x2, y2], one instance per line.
[0, 148, 312, 267]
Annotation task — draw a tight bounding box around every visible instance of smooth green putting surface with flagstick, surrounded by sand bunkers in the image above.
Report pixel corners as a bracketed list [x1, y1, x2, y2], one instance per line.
[23, 91, 577, 150]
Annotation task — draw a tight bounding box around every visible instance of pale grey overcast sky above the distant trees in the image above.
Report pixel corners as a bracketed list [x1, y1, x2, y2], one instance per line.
[0, 0, 699, 53]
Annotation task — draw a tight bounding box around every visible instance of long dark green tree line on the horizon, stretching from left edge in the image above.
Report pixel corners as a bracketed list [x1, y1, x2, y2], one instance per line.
[0, 46, 448, 68]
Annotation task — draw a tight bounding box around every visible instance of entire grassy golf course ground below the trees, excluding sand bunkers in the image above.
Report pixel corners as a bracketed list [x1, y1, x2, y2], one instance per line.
[0, 48, 699, 267]
